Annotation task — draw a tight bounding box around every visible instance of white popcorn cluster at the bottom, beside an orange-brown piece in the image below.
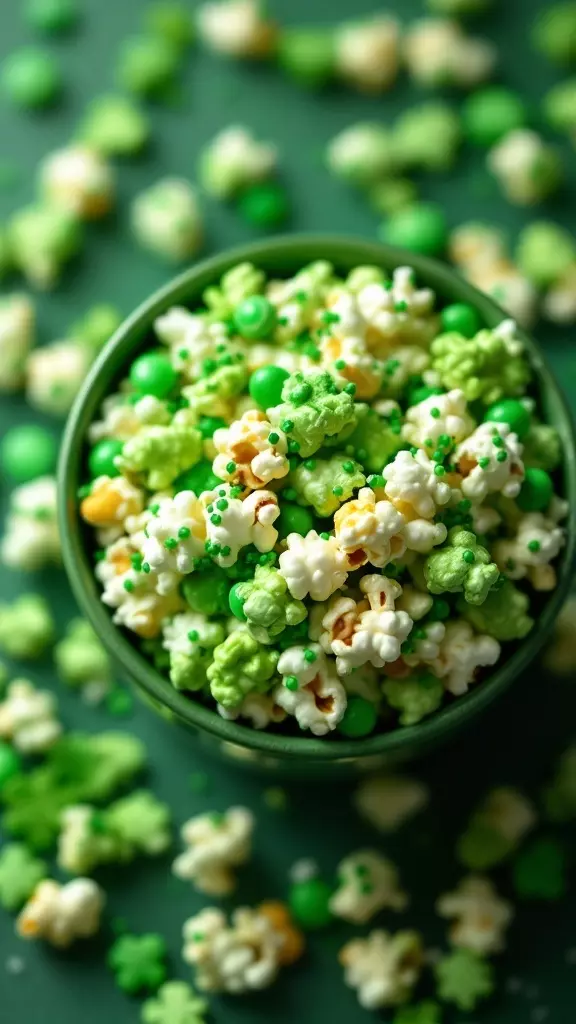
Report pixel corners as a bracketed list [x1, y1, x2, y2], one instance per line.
[182, 907, 285, 995]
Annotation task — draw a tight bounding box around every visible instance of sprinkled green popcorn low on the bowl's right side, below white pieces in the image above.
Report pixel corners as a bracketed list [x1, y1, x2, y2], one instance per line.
[424, 526, 500, 604]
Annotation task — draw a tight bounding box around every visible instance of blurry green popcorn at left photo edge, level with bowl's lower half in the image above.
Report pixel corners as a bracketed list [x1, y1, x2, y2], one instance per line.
[0, 594, 54, 660]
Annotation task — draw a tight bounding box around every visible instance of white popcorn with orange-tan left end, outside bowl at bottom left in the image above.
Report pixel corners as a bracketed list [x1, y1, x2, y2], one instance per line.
[16, 879, 106, 949]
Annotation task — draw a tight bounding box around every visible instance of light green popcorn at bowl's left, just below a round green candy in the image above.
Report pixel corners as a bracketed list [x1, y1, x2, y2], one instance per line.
[119, 424, 202, 490]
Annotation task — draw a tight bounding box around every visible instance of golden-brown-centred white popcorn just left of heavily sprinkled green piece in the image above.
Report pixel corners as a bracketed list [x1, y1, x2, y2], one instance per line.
[212, 409, 290, 489]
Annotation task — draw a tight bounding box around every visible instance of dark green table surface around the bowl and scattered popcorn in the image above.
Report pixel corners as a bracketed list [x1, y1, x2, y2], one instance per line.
[0, 0, 576, 1024]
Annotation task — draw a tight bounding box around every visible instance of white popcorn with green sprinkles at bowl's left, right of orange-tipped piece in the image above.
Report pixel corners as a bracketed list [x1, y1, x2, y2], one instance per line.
[141, 490, 207, 594]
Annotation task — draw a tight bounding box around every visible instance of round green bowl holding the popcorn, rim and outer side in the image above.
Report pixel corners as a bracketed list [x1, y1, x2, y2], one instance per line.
[58, 236, 576, 777]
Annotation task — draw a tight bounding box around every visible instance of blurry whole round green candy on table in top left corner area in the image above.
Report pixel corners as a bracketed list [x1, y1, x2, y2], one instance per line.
[1, 46, 63, 111]
